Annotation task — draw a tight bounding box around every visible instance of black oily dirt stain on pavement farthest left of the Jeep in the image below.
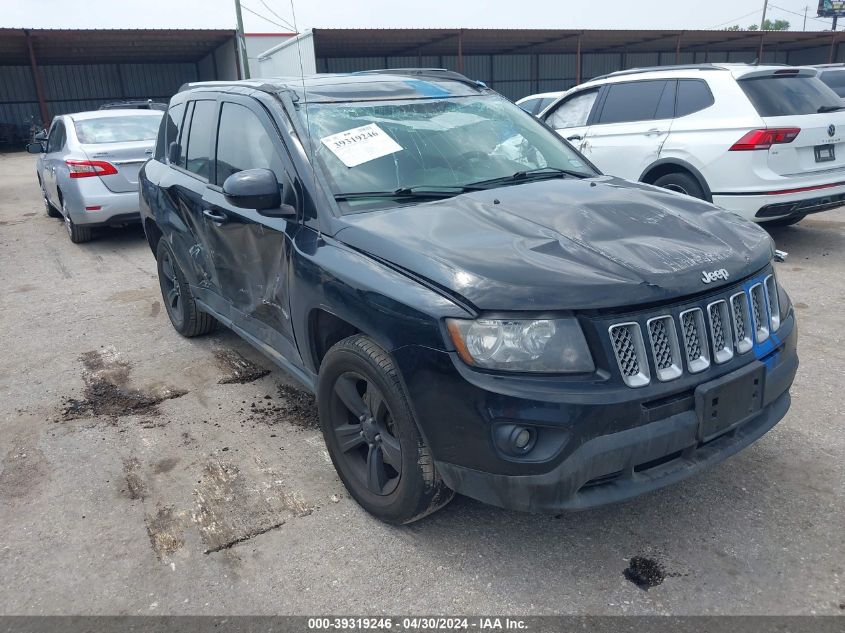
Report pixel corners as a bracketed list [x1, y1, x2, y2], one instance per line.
[61, 348, 187, 420]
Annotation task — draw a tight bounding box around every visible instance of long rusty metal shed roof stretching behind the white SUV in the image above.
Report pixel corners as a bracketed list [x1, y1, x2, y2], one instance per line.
[313, 28, 841, 58]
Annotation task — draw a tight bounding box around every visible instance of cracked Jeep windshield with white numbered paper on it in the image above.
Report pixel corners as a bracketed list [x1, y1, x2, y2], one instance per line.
[300, 97, 595, 212]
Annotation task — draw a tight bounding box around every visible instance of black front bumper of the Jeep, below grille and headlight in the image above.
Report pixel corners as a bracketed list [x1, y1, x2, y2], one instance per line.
[394, 316, 798, 512]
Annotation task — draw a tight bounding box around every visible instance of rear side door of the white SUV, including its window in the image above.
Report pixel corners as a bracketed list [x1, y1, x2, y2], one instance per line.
[581, 79, 677, 180]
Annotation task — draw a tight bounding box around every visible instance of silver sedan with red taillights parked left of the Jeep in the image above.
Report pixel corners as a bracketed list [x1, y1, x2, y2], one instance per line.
[27, 110, 163, 244]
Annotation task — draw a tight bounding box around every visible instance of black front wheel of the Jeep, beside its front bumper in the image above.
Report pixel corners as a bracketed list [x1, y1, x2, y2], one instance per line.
[317, 335, 454, 525]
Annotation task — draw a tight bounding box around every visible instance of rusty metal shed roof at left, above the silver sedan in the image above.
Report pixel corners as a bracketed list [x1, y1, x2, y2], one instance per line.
[0, 28, 235, 65]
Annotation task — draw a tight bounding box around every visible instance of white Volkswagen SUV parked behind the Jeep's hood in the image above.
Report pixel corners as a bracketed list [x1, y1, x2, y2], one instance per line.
[540, 64, 845, 224]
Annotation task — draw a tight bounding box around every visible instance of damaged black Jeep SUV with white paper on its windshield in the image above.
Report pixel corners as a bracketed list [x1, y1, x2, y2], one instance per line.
[140, 70, 798, 523]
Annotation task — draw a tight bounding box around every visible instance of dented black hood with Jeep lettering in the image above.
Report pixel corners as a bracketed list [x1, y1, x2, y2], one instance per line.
[337, 177, 774, 310]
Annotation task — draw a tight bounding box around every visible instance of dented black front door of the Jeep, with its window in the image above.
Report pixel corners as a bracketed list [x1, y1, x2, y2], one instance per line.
[203, 95, 299, 360]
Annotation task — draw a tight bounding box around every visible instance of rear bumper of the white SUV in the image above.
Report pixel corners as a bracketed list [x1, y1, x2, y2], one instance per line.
[713, 180, 845, 222]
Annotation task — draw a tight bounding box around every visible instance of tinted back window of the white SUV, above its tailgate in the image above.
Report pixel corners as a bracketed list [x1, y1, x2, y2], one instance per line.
[739, 75, 842, 117]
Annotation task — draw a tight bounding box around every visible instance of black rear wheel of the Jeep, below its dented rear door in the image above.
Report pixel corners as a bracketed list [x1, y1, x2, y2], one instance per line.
[156, 239, 217, 338]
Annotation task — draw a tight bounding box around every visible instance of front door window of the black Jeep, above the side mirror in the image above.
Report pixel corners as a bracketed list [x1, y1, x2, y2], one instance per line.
[217, 103, 282, 185]
